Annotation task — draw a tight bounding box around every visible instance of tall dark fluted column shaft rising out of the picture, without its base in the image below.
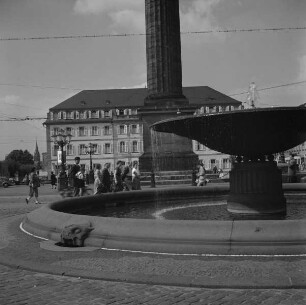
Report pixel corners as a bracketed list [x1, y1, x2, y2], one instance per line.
[145, 0, 183, 99]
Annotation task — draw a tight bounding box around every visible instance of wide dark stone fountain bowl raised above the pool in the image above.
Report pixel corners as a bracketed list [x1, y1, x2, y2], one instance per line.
[151, 107, 306, 157]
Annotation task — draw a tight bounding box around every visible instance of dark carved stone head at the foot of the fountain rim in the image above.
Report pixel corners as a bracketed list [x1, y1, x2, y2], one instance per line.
[61, 224, 94, 247]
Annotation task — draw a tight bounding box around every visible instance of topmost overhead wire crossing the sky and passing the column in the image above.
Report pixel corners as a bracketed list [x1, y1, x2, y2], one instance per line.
[0, 26, 306, 41]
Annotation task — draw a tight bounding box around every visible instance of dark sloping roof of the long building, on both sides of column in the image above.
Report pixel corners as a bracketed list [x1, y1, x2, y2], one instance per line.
[50, 86, 241, 111]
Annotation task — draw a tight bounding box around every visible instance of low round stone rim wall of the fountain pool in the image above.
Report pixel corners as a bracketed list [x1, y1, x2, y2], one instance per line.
[22, 186, 306, 255]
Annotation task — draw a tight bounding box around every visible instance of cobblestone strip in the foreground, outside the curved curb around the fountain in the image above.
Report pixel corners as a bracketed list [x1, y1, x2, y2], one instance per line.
[0, 266, 306, 305]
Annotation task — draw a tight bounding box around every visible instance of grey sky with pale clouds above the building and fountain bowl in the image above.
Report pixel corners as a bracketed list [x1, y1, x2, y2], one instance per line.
[0, 0, 306, 160]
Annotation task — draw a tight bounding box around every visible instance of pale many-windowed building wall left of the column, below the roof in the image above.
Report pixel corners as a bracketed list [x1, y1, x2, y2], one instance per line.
[47, 110, 143, 172]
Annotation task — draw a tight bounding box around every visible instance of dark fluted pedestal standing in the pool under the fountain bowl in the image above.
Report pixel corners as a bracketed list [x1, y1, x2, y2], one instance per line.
[227, 161, 286, 216]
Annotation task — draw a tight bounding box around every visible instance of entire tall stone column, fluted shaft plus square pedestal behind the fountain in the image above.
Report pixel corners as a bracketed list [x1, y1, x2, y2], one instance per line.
[139, 0, 198, 171]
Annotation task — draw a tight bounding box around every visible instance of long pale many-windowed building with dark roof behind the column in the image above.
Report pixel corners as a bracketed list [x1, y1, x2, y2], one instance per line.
[44, 86, 241, 172]
